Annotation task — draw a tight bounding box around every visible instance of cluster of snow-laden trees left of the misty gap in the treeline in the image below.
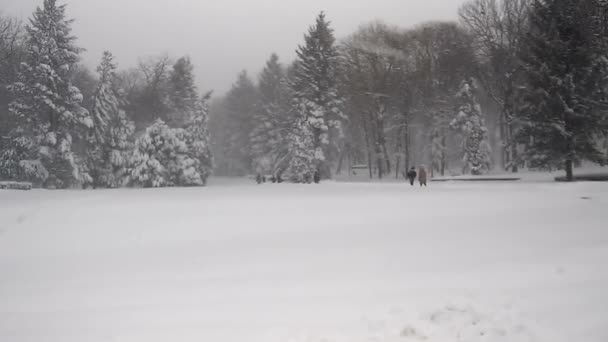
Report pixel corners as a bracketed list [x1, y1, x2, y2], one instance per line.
[0, 0, 212, 188]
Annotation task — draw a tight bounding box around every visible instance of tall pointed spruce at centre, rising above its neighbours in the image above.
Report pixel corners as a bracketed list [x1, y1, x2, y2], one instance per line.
[291, 13, 344, 178]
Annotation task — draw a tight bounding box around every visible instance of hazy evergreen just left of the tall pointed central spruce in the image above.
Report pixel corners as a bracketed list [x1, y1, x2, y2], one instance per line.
[251, 54, 291, 173]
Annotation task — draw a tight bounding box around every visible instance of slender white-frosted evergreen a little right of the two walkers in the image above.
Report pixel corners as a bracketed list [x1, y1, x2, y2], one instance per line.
[450, 80, 491, 175]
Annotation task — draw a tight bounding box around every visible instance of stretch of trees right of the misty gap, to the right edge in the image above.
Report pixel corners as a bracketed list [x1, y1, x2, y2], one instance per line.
[210, 0, 608, 182]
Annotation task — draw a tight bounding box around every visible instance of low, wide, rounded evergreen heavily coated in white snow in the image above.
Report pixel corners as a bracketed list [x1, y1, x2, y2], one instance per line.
[129, 119, 203, 188]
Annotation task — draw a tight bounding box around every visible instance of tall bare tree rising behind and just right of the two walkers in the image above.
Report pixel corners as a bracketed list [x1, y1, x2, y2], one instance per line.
[410, 22, 476, 175]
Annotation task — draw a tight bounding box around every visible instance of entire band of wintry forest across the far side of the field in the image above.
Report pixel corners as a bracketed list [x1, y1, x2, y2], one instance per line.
[0, 0, 608, 188]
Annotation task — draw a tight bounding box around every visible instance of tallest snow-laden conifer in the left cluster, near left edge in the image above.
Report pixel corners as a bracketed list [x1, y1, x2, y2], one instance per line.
[5, 0, 93, 188]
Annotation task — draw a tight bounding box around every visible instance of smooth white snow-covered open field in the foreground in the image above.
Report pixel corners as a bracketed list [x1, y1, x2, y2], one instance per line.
[0, 180, 608, 342]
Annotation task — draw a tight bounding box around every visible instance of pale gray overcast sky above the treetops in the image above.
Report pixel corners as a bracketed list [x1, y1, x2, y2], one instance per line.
[0, 0, 464, 94]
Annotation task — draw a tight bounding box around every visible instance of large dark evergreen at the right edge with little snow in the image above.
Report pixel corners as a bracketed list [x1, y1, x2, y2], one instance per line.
[517, 0, 607, 180]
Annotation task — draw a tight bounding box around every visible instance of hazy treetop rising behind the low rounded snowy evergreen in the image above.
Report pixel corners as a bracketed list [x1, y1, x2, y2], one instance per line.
[167, 57, 199, 127]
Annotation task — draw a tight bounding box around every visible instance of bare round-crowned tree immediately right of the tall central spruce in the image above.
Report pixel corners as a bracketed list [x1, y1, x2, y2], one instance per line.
[341, 23, 406, 178]
